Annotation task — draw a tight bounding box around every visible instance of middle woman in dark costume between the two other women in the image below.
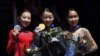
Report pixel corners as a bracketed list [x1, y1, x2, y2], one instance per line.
[34, 8, 64, 56]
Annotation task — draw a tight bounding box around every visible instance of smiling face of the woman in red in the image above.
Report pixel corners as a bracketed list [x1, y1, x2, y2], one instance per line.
[20, 11, 31, 27]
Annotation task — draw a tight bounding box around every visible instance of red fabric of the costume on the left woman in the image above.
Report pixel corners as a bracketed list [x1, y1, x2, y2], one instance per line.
[7, 30, 34, 56]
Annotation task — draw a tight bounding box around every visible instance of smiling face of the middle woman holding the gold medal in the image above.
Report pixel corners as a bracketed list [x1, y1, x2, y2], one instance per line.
[42, 11, 54, 26]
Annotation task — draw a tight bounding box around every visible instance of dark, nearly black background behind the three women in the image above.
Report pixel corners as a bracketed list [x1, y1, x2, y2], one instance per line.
[0, 0, 100, 56]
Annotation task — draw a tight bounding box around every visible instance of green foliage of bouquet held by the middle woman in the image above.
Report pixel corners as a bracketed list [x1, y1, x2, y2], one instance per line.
[41, 27, 62, 42]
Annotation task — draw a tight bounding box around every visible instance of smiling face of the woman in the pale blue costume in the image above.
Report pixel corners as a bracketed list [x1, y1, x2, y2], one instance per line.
[68, 10, 79, 26]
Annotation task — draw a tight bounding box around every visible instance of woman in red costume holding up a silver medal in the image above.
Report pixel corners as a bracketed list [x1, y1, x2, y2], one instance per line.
[6, 10, 34, 56]
